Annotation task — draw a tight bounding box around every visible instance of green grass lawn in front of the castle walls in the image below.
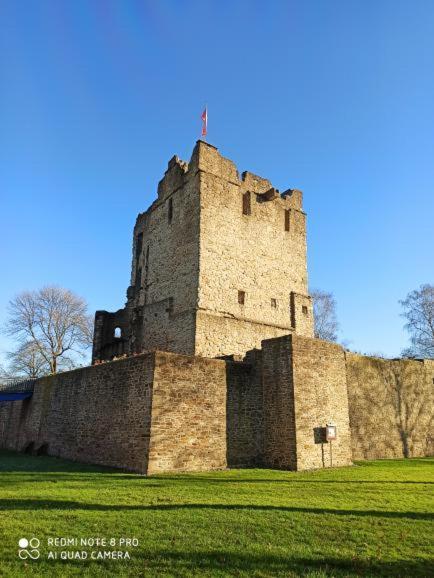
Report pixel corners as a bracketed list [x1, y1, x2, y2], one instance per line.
[0, 452, 434, 577]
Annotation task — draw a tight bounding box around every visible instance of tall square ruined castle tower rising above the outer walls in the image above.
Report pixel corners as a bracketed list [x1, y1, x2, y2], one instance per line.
[92, 141, 313, 361]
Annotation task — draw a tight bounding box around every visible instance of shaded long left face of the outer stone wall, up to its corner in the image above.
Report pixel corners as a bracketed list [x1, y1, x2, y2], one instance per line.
[0, 354, 154, 472]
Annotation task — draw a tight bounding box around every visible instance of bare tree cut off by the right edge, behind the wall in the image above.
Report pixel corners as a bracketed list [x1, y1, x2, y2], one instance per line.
[399, 284, 434, 358]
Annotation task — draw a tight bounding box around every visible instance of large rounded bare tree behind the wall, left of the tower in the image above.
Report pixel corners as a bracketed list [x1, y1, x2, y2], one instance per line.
[5, 286, 92, 373]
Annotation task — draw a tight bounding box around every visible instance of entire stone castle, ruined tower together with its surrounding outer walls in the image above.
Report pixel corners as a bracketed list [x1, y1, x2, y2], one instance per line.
[0, 141, 434, 474]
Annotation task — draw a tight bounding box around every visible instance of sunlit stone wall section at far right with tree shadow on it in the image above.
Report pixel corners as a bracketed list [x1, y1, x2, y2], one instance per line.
[346, 353, 434, 460]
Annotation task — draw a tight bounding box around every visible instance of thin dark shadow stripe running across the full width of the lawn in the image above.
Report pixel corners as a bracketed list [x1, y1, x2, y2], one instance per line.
[0, 499, 434, 520]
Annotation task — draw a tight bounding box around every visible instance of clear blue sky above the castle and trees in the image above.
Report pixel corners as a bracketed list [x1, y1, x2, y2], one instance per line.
[0, 0, 434, 362]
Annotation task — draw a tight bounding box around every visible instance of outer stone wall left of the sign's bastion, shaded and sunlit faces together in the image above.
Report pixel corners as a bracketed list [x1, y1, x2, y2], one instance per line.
[0, 351, 262, 473]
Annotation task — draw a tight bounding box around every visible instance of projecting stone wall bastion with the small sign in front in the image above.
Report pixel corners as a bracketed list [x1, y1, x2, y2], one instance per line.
[262, 335, 351, 470]
